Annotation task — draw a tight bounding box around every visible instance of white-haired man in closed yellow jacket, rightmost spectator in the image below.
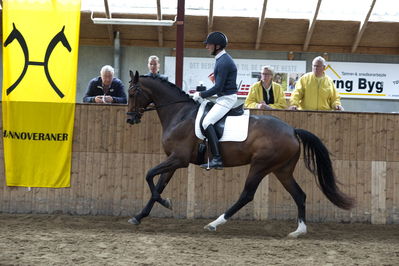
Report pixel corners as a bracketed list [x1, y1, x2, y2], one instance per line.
[289, 56, 344, 111]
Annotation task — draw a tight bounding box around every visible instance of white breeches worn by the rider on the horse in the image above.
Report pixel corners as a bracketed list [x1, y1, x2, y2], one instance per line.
[202, 94, 237, 129]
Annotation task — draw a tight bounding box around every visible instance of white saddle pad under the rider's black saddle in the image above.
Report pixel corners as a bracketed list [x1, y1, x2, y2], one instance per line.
[195, 100, 249, 141]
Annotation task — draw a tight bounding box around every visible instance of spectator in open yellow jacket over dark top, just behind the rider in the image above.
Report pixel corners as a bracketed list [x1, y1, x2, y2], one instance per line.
[244, 66, 287, 110]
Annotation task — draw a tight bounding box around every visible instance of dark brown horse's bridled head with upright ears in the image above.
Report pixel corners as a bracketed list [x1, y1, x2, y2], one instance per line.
[126, 70, 152, 124]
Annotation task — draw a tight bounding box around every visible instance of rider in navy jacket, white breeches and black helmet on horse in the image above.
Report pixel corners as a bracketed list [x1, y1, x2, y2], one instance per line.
[193, 31, 237, 169]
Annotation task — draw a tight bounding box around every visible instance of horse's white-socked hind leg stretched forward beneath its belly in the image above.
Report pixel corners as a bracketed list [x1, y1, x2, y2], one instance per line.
[204, 163, 267, 231]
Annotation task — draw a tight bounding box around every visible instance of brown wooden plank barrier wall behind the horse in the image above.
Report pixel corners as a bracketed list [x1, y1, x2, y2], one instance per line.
[0, 104, 399, 223]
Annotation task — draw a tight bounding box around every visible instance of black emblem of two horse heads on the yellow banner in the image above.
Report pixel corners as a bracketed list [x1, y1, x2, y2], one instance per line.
[4, 23, 72, 98]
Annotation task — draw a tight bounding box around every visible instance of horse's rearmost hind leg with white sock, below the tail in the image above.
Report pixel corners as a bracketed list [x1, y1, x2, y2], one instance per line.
[274, 156, 307, 238]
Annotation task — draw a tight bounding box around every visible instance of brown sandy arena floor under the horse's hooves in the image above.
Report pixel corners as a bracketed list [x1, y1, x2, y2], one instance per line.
[0, 214, 399, 265]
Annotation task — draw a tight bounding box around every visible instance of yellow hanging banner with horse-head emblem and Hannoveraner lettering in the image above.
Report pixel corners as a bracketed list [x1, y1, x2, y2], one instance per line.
[2, 0, 80, 187]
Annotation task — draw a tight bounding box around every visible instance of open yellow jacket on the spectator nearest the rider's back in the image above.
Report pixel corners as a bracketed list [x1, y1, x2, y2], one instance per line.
[244, 81, 287, 109]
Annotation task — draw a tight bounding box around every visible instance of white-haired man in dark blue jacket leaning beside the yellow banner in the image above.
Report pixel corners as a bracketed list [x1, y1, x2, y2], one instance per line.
[83, 65, 127, 103]
